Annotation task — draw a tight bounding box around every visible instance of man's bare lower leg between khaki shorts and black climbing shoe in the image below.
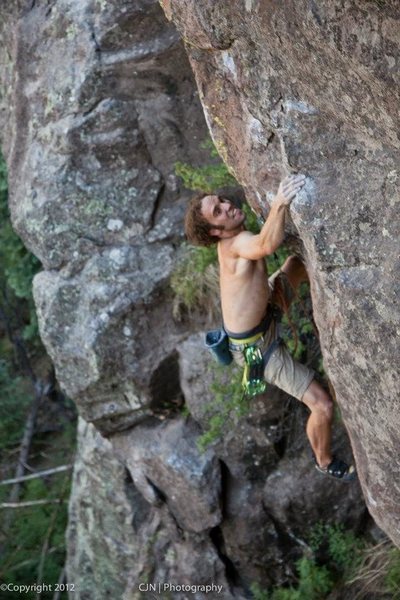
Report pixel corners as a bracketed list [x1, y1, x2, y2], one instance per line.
[302, 379, 333, 468]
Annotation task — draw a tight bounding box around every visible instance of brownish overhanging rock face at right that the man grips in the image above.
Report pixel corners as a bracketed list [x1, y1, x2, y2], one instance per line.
[163, 0, 400, 544]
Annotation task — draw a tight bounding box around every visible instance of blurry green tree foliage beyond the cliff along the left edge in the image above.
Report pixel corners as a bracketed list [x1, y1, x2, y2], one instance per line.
[0, 155, 75, 600]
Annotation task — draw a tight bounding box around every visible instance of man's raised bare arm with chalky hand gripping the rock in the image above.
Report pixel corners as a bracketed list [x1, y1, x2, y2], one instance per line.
[231, 175, 305, 260]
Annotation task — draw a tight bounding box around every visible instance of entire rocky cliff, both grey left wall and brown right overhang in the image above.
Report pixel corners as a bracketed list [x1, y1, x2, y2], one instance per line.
[0, 0, 398, 600]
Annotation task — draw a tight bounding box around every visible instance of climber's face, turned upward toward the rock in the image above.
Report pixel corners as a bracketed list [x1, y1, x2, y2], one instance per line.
[201, 196, 246, 237]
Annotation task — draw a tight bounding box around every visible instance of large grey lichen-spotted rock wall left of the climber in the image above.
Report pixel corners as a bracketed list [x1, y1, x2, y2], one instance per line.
[2, 0, 211, 433]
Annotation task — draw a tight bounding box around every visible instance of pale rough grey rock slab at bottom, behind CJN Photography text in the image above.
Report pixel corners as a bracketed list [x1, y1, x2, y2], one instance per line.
[67, 419, 239, 600]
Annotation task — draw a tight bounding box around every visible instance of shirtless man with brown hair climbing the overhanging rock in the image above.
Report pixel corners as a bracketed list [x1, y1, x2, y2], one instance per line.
[185, 175, 355, 480]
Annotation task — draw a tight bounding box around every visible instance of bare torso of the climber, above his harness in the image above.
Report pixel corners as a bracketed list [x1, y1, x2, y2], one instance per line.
[218, 233, 270, 333]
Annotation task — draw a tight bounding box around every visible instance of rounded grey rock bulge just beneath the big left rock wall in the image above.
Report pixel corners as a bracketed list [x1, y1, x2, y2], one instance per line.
[113, 419, 222, 533]
